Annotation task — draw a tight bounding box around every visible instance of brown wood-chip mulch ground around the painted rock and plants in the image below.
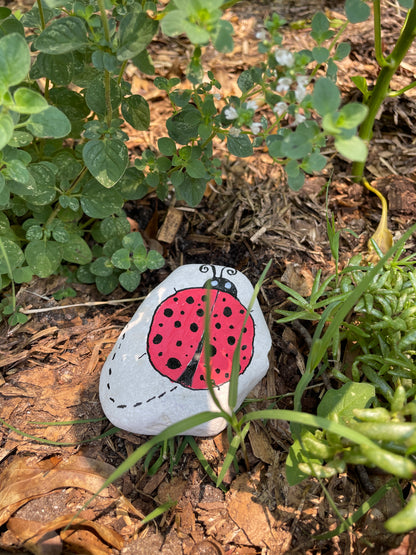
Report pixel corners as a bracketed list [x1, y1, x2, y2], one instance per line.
[0, 0, 416, 555]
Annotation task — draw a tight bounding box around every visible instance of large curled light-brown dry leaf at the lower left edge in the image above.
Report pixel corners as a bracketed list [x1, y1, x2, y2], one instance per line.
[0, 455, 114, 525]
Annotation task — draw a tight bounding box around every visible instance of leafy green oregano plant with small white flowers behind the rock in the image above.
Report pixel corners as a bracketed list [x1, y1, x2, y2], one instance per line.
[0, 0, 413, 324]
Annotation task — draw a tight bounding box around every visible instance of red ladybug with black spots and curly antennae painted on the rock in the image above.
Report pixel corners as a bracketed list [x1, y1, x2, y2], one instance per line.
[147, 266, 254, 389]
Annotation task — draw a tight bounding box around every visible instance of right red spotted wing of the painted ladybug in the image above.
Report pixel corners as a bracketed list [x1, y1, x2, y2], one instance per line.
[192, 292, 254, 389]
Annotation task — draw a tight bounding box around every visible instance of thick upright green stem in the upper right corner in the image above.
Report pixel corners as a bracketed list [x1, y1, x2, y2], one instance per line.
[352, 7, 416, 181]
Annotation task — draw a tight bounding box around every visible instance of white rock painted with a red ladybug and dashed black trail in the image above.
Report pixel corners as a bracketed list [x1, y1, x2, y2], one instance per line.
[100, 264, 271, 436]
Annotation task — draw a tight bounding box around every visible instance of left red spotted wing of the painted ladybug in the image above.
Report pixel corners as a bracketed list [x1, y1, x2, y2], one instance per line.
[147, 288, 215, 382]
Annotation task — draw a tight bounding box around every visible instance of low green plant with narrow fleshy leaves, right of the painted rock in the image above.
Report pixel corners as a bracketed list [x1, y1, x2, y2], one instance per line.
[278, 226, 416, 533]
